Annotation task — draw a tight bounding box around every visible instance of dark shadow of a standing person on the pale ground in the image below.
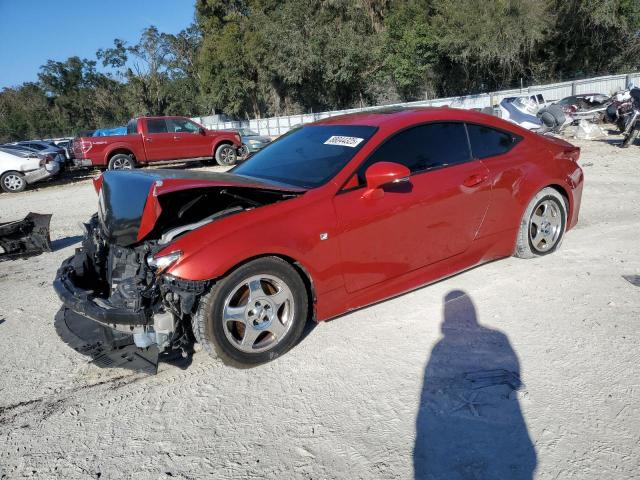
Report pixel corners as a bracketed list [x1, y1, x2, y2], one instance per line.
[413, 290, 536, 480]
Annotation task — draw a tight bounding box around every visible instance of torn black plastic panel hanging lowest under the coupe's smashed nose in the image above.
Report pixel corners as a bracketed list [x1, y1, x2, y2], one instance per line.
[54, 308, 159, 375]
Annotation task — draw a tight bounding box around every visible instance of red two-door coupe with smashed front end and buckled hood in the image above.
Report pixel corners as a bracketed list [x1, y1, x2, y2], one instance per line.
[54, 108, 583, 365]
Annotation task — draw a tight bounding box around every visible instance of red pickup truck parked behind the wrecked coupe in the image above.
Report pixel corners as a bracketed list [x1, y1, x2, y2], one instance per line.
[73, 117, 242, 170]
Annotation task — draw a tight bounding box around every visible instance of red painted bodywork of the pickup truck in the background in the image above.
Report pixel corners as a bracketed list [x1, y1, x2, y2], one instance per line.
[73, 117, 240, 167]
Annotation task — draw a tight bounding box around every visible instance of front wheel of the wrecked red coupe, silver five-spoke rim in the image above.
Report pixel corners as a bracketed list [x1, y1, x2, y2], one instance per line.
[192, 257, 309, 367]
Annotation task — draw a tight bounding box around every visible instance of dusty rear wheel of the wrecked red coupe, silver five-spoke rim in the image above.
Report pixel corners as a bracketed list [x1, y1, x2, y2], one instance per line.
[514, 187, 567, 258]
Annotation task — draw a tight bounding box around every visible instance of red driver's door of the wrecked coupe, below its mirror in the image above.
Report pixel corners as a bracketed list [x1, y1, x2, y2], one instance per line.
[334, 160, 491, 292]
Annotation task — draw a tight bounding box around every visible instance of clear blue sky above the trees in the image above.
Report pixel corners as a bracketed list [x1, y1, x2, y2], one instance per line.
[0, 0, 194, 89]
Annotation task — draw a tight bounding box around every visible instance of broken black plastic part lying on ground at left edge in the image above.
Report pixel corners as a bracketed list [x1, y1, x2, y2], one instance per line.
[0, 213, 51, 261]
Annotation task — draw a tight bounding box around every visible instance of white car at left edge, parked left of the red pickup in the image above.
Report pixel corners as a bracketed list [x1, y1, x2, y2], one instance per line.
[0, 146, 60, 193]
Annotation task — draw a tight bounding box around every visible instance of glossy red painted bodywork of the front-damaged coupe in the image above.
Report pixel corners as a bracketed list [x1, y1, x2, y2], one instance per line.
[142, 108, 583, 320]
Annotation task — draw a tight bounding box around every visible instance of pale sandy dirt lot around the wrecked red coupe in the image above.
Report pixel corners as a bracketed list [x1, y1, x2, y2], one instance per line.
[0, 141, 640, 480]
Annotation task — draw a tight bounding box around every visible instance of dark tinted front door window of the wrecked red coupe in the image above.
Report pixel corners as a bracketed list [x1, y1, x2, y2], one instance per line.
[358, 123, 471, 185]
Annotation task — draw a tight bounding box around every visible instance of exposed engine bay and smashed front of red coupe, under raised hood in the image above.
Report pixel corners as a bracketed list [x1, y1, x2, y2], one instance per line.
[54, 171, 299, 373]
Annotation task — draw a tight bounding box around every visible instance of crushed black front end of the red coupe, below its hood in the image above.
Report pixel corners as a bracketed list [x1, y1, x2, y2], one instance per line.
[54, 215, 208, 373]
